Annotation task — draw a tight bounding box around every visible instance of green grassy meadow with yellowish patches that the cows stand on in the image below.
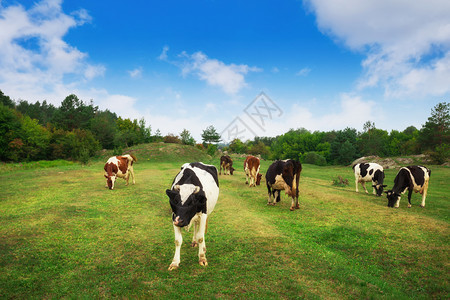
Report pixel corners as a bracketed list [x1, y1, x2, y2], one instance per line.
[0, 144, 450, 299]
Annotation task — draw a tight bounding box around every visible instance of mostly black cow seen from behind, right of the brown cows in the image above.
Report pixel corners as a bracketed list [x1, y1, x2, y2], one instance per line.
[266, 159, 302, 210]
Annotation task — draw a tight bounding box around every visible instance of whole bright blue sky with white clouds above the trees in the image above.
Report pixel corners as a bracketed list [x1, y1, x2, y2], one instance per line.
[0, 0, 450, 141]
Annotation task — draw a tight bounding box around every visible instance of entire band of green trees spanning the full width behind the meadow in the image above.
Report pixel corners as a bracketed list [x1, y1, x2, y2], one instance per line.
[0, 90, 450, 165]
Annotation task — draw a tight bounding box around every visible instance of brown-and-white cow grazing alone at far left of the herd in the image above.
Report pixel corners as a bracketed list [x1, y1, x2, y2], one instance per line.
[104, 154, 137, 190]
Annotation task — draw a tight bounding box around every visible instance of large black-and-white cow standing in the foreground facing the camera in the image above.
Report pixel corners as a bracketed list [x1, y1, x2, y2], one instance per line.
[166, 162, 219, 271]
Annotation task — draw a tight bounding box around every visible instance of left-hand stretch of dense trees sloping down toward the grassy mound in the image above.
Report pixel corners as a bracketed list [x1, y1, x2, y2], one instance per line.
[0, 91, 154, 162]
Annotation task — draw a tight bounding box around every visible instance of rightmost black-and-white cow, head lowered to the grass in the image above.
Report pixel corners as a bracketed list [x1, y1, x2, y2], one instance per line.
[385, 166, 431, 207]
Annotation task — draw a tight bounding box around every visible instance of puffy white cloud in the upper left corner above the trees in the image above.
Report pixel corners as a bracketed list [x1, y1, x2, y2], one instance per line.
[0, 0, 105, 104]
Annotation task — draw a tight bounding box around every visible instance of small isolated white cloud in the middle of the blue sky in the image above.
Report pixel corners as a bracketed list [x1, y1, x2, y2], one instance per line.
[180, 52, 262, 95]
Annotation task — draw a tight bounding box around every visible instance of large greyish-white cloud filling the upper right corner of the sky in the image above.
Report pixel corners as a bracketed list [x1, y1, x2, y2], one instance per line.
[304, 0, 450, 97]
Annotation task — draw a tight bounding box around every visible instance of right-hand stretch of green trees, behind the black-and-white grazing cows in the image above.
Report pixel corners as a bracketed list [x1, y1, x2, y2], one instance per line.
[223, 102, 450, 165]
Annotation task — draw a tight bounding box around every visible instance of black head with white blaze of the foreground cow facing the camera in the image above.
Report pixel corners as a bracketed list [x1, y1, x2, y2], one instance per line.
[166, 184, 206, 227]
